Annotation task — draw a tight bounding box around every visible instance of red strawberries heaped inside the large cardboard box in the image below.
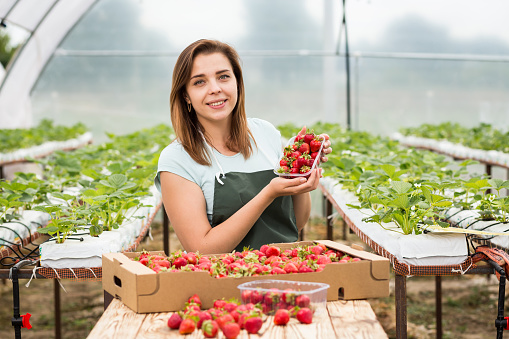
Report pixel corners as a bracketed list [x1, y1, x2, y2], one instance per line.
[133, 244, 361, 278]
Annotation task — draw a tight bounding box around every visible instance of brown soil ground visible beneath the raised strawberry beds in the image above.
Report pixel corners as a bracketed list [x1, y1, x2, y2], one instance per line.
[0, 218, 500, 339]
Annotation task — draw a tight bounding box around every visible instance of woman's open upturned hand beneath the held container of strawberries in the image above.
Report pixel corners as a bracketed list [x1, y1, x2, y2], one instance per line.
[265, 168, 321, 199]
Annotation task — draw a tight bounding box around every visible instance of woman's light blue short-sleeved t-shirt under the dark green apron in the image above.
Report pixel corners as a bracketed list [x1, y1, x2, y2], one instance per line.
[154, 118, 283, 223]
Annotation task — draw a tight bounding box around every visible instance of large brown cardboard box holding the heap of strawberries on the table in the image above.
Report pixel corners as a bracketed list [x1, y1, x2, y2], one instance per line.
[102, 240, 390, 313]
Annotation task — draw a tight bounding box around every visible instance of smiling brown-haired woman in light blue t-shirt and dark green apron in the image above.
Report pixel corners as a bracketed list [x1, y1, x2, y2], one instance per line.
[155, 40, 331, 253]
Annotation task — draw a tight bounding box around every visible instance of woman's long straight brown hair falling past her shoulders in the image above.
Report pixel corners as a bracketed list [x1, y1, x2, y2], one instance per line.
[170, 39, 256, 166]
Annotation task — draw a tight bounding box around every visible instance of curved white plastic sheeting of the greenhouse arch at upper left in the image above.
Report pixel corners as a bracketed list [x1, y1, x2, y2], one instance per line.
[0, 0, 96, 128]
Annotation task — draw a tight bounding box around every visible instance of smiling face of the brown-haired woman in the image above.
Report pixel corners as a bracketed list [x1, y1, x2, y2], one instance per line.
[186, 53, 237, 124]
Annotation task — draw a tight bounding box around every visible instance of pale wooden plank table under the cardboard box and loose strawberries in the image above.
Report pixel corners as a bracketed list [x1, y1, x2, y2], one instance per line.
[88, 299, 388, 339]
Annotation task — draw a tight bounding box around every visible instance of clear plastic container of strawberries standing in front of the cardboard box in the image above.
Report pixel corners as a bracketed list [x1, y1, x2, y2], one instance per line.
[237, 280, 330, 316]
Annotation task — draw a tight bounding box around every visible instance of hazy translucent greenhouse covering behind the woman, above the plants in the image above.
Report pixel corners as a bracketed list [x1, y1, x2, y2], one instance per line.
[0, 0, 509, 138]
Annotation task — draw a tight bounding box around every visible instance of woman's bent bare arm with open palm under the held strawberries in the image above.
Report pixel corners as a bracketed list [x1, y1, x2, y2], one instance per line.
[160, 172, 318, 254]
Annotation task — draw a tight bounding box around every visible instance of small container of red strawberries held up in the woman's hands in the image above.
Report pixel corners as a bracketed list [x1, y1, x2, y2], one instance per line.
[276, 130, 324, 178]
